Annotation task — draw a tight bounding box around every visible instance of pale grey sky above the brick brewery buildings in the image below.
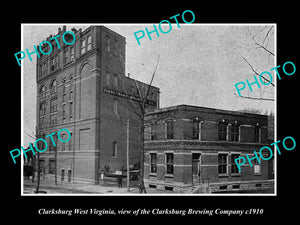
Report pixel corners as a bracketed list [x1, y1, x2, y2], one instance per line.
[21, 23, 276, 146]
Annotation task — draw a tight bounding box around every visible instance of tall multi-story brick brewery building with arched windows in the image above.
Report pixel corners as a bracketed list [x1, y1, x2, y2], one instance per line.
[36, 26, 159, 184]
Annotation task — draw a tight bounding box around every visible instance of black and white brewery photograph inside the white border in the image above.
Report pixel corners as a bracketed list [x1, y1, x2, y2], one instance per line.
[20, 22, 276, 195]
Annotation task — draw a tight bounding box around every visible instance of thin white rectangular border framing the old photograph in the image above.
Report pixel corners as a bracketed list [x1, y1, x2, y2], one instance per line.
[20, 23, 277, 197]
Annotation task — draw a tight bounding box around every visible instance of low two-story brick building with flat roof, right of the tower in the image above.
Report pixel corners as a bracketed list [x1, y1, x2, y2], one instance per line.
[144, 105, 273, 192]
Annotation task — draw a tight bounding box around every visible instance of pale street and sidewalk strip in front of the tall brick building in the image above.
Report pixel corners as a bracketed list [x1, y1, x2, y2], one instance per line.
[23, 177, 138, 195]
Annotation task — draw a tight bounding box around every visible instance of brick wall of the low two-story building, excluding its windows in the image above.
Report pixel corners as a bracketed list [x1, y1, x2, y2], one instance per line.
[144, 105, 269, 192]
